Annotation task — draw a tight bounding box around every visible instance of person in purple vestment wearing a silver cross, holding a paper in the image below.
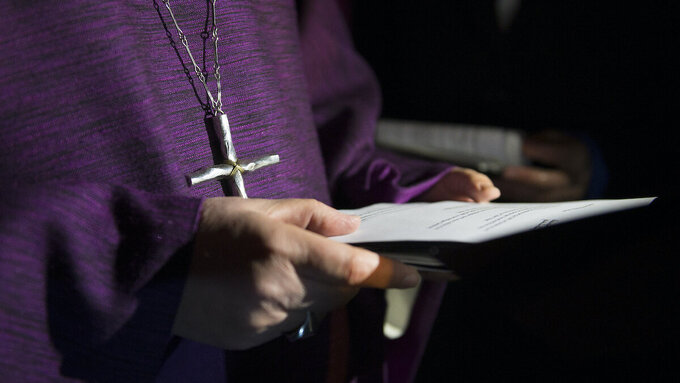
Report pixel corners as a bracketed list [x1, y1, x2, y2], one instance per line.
[0, 0, 499, 382]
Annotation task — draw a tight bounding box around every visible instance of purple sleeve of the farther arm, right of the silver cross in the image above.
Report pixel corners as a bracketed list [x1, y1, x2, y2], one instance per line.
[300, 0, 451, 207]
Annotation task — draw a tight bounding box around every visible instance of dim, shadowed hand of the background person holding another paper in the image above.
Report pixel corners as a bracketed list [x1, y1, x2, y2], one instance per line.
[494, 130, 591, 202]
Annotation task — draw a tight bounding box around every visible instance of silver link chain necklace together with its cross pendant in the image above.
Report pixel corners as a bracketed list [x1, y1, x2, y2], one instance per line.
[159, 0, 279, 198]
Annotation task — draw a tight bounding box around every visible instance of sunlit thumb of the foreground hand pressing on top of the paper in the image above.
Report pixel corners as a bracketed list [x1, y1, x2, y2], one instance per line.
[268, 199, 361, 237]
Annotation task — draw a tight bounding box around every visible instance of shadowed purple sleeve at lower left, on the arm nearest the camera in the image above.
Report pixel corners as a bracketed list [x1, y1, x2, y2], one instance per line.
[0, 183, 201, 382]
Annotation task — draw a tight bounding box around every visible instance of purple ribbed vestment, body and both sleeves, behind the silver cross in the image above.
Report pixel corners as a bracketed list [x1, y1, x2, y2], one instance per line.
[0, 0, 454, 382]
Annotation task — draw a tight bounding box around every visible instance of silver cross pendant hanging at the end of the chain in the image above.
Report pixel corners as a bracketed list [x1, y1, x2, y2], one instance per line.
[186, 114, 279, 198]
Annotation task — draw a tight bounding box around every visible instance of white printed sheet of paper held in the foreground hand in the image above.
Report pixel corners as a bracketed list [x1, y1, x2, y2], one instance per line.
[332, 197, 655, 243]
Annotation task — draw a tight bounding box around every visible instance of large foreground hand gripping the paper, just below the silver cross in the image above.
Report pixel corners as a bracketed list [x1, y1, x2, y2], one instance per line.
[173, 197, 419, 349]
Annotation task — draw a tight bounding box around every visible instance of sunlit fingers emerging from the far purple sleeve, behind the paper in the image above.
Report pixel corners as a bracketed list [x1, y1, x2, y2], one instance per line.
[417, 168, 501, 202]
